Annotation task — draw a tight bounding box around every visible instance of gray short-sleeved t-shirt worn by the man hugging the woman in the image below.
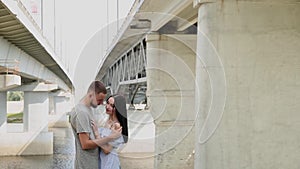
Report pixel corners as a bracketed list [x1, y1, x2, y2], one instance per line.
[70, 104, 99, 169]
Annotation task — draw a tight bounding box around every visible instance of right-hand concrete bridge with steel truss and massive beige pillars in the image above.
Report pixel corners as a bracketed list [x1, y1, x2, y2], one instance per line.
[1, 0, 300, 169]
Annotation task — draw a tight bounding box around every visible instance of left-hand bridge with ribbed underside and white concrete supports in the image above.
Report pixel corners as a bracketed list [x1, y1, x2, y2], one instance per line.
[0, 1, 73, 155]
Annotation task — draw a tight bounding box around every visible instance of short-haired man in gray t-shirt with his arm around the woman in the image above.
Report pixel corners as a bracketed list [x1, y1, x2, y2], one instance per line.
[70, 81, 122, 169]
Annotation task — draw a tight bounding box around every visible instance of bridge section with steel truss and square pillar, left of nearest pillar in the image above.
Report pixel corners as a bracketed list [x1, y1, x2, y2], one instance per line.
[96, 0, 198, 168]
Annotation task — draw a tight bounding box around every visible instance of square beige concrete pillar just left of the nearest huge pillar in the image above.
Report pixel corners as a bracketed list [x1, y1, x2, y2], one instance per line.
[146, 34, 197, 169]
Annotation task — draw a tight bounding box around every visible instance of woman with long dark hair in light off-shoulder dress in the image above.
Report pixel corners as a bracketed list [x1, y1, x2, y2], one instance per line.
[93, 95, 128, 169]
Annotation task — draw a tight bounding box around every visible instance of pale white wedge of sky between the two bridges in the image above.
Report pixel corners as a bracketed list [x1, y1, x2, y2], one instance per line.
[21, 0, 135, 100]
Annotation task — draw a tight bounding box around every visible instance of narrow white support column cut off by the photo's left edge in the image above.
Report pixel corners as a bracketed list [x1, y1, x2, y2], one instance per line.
[0, 91, 7, 133]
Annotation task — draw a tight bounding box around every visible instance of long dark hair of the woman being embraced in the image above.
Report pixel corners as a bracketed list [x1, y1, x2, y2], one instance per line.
[106, 94, 128, 143]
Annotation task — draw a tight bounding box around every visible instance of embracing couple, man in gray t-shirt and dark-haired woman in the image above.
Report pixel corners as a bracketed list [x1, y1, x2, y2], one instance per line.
[70, 81, 128, 169]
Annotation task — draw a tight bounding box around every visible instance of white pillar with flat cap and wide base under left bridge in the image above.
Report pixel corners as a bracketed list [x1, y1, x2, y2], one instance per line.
[0, 83, 57, 156]
